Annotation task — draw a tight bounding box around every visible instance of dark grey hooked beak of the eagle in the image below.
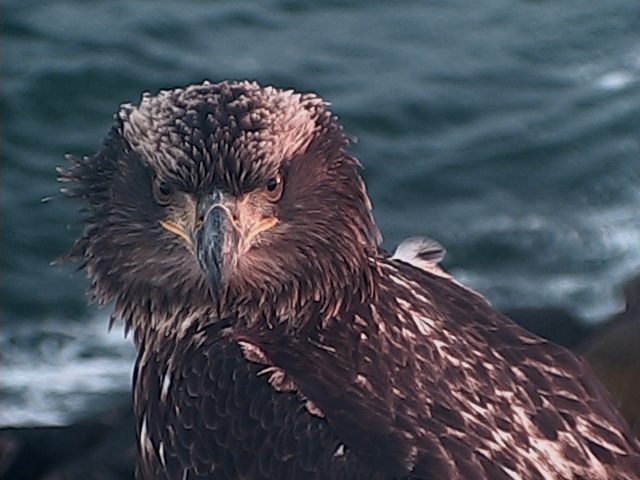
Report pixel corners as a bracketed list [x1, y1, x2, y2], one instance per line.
[194, 192, 239, 295]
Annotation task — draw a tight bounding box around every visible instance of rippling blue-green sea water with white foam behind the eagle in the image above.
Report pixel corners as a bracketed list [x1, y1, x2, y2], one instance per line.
[0, 0, 640, 424]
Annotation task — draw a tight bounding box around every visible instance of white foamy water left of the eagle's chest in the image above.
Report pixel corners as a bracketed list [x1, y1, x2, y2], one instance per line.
[0, 315, 135, 426]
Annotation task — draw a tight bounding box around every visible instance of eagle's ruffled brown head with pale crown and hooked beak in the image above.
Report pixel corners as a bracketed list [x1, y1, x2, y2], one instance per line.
[58, 82, 380, 334]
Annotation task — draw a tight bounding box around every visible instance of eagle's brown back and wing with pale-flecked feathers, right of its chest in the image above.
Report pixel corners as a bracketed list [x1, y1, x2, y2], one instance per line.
[234, 259, 640, 479]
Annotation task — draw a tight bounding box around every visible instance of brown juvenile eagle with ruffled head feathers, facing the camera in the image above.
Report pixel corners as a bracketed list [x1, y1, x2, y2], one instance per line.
[59, 82, 640, 479]
